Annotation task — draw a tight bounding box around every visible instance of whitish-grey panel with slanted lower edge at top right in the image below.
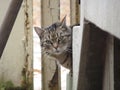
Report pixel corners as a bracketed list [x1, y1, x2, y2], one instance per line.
[81, 0, 120, 38]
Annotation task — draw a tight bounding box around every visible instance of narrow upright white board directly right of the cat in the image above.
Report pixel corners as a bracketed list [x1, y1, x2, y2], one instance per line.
[72, 26, 83, 90]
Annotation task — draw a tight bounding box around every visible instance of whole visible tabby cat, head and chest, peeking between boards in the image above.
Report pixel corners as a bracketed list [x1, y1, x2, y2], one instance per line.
[34, 16, 72, 86]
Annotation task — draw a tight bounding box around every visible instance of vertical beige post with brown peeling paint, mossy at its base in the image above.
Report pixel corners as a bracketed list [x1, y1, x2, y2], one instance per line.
[22, 0, 33, 89]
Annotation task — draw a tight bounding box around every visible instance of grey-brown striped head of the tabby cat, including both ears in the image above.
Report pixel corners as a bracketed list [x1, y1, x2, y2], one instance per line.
[35, 17, 71, 55]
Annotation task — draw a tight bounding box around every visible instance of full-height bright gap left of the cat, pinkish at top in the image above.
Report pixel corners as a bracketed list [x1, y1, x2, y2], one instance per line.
[33, 0, 42, 90]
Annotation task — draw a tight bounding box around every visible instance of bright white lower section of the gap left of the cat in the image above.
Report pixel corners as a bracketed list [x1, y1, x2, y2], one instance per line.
[33, 30, 42, 90]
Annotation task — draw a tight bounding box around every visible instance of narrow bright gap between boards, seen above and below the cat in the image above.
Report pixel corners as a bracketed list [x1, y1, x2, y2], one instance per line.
[60, 0, 70, 90]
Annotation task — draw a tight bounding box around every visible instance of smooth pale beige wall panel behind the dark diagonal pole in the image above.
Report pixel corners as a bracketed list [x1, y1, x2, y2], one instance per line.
[0, 0, 25, 85]
